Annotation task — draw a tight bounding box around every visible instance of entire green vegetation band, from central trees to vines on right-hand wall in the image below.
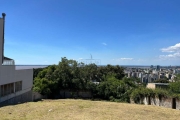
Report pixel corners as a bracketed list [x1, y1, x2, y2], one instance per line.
[33, 57, 180, 103]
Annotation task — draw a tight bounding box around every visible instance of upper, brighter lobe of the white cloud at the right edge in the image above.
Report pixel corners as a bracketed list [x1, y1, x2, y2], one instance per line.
[161, 43, 180, 52]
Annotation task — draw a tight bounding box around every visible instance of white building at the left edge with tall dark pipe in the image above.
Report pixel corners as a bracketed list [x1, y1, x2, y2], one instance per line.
[0, 13, 33, 104]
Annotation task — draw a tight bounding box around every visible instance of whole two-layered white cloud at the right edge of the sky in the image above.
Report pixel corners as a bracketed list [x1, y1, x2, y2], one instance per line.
[159, 43, 180, 60]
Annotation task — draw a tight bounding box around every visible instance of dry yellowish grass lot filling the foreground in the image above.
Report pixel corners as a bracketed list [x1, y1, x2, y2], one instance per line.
[0, 99, 180, 120]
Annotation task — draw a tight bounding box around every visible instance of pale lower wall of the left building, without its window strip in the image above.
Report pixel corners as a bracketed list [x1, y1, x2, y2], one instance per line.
[0, 65, 33, 102]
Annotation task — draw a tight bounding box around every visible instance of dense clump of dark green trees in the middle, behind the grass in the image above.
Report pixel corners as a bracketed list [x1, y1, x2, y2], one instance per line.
[33, 57, 128, 101]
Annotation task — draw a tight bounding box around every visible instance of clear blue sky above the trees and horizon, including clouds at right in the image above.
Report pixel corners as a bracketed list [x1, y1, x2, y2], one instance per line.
[0, 0, 180, 65]
